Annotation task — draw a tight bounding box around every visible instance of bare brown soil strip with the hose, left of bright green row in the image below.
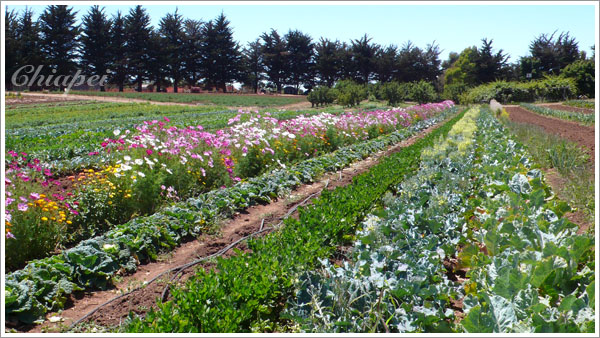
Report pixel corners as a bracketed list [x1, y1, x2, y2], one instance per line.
[18, 116, 443, 333]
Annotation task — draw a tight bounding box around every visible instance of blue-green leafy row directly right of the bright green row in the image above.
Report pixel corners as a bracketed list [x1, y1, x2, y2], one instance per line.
[285, 108, 481, 333]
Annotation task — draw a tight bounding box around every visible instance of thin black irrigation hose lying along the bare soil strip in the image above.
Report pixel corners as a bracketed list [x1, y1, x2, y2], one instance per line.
[68, 191, 322, 331]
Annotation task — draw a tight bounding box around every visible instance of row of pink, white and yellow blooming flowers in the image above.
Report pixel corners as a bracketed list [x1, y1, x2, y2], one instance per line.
[5, 102, 452, 270]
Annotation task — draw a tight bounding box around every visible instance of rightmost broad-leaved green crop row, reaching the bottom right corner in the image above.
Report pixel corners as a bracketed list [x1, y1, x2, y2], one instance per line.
[458, 109, 595, 332]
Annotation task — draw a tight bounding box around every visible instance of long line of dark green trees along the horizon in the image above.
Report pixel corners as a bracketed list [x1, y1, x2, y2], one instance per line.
[5, 5, 595, 98]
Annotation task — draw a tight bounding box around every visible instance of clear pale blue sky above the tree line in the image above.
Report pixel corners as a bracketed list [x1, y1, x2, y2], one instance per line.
[7, 2, 597, 62]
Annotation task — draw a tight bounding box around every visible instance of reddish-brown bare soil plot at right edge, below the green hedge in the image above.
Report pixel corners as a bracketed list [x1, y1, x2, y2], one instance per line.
[505, 106, 595, 164]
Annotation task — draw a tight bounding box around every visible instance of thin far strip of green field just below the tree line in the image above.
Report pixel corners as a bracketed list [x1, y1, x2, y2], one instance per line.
[48, 90, 306, 108]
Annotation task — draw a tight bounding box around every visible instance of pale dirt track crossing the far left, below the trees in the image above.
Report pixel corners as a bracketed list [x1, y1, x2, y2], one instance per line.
[14, 93, 310, 110]
